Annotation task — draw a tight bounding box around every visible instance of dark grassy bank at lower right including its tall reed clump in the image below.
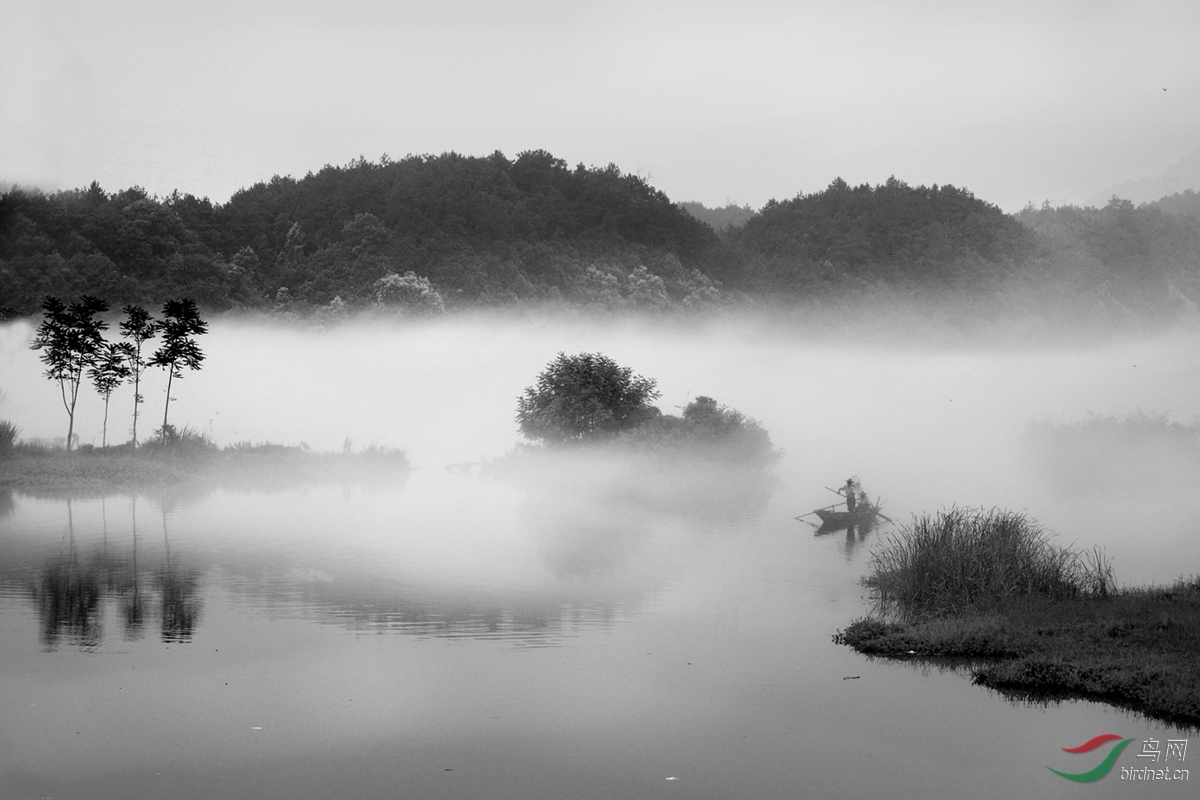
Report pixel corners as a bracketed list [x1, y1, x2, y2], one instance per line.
[834, 510, 1200, 727]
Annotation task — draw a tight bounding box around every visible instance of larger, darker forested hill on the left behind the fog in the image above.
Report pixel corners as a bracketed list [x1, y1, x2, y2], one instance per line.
[0, 151, 719, 313]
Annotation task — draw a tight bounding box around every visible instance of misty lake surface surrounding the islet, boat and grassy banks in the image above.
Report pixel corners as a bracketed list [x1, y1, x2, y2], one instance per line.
[0, 317, 1200, 800]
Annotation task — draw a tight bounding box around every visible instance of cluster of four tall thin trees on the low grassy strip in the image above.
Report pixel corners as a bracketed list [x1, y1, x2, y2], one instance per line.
[30, 295, 208, 451]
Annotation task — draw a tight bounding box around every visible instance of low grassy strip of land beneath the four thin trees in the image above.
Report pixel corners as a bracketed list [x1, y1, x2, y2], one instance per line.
[0, 429, 412, 493]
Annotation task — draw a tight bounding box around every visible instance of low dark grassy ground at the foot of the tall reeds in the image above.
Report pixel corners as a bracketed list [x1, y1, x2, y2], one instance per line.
[834, 577, 1200, 728]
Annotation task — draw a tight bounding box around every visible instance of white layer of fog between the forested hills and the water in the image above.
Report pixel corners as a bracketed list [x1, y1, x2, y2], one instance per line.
[0, 315, 1200, 581]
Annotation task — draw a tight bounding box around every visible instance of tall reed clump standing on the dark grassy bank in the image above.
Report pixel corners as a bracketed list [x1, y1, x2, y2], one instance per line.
[863, 509, 1115, 616]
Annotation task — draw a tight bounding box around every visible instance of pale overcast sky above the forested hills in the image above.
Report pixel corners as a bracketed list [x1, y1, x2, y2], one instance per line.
[0, 0, 1200, 211]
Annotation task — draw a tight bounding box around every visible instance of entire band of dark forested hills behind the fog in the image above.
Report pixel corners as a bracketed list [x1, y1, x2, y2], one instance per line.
[7, 150, 1200, 319]
